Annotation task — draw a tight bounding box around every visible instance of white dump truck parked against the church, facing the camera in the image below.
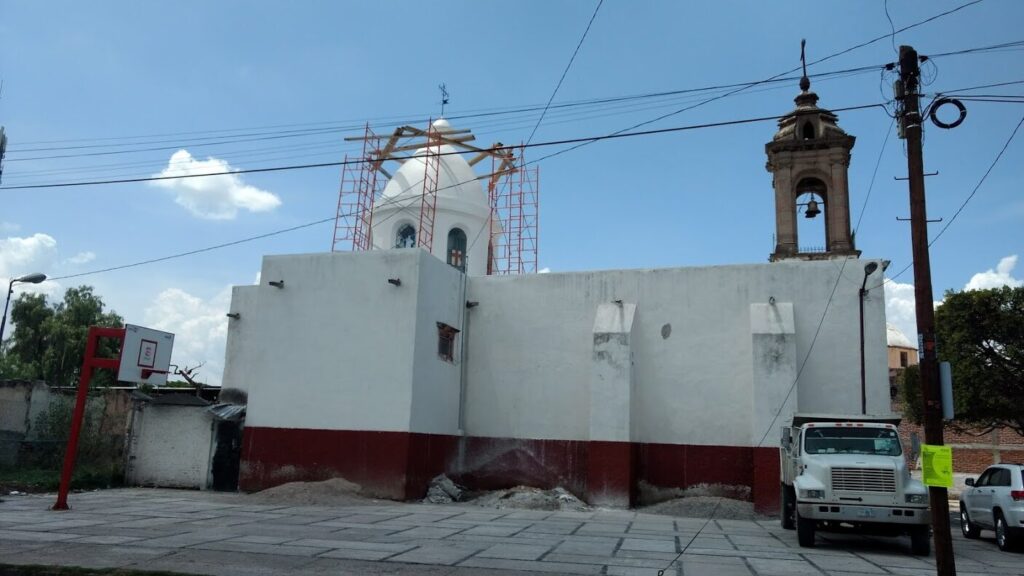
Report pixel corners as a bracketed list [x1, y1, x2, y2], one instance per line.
[779, 414, 931, 556]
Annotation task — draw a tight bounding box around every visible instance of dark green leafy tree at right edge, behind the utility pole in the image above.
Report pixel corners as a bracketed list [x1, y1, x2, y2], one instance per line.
[935, 286, 1024, 436]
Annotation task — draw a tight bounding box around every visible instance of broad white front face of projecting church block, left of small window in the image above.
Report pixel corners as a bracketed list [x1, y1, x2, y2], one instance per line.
[240, 249, 422, 431]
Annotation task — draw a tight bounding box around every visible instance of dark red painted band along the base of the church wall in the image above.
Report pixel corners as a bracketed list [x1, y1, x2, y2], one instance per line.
[239, 426, 779, 513]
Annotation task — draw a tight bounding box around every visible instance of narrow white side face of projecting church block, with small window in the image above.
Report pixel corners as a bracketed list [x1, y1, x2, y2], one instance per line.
[410, 250, 466, 436]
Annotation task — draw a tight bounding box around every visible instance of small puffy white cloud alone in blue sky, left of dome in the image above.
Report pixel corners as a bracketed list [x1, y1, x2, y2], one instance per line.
[153, 150, 281, 220]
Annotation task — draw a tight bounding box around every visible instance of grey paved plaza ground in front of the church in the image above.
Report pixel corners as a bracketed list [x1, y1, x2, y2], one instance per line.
[0, 489, 1024, 576]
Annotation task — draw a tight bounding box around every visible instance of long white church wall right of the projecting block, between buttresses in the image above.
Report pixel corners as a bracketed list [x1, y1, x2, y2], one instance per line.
[466, 260, 888, 446]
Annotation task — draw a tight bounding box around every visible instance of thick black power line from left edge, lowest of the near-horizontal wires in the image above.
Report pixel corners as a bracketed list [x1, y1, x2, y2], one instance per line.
[0, 104, 885, 190]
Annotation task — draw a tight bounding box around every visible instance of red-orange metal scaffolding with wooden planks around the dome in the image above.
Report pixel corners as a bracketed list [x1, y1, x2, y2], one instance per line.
[332, 123, 540, 275]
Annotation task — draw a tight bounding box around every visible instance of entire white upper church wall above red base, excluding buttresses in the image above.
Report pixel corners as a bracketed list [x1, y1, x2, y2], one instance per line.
[225, 249, 889, 446]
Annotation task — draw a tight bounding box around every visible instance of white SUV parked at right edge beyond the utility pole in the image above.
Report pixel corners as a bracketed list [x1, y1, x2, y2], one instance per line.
[959, 464, 1024, 550]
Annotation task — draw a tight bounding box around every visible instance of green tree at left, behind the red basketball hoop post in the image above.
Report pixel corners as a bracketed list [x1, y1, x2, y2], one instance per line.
[0, 286, 124, 385]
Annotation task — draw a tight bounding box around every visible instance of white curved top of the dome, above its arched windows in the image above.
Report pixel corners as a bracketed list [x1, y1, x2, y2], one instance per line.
[379, 119, 489, 211]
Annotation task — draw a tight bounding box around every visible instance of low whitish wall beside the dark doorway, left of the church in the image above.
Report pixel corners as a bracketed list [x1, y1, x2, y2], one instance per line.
[127, 404, 213, 489]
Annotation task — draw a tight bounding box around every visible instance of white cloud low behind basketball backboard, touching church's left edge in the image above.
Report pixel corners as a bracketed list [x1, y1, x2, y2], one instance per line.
[143, 286, 231, 385]
